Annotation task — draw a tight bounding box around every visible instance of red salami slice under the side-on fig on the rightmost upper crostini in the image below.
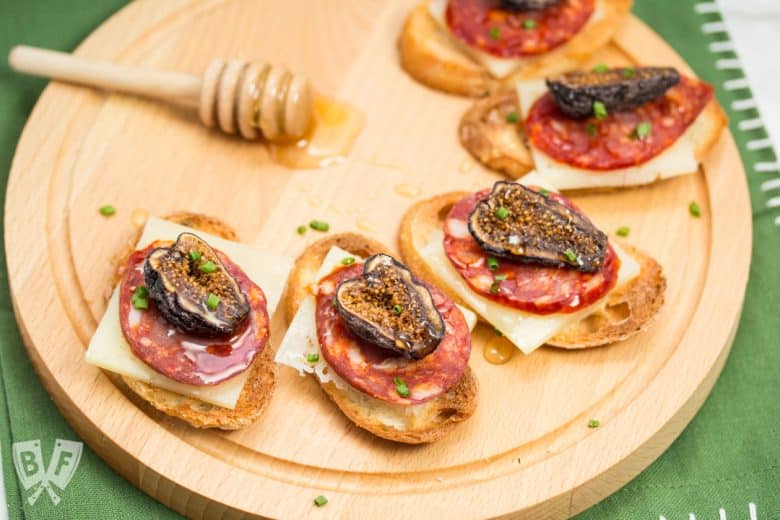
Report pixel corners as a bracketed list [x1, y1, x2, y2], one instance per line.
[525, 77, 714, 171]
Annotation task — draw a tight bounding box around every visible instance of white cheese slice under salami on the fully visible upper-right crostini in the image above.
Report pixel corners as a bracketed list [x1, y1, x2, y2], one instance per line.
[516, 80, 707, 190]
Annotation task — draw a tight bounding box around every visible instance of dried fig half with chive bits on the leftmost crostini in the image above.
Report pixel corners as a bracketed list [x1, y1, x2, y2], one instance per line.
[144, 233, 250, 336]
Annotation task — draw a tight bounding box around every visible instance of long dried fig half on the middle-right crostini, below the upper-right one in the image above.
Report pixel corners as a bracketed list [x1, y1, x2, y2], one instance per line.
[469, 181, 607, 272]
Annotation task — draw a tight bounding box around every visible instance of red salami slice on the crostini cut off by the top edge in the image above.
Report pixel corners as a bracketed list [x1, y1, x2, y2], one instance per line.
[446, 0, 596, 58]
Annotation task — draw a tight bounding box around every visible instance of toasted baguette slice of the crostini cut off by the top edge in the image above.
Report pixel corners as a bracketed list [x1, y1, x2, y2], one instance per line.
[398, 0, 631, 97]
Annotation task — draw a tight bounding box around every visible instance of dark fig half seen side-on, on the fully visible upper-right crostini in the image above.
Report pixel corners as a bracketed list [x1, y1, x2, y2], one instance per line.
[547, 67, 680, 119]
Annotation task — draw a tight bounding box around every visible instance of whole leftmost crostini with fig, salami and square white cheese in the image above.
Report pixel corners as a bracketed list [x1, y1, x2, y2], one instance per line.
[86, 213, 292, 430]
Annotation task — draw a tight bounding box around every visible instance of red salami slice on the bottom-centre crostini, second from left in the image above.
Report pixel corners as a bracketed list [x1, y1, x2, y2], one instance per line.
[316, 264, 471, 405]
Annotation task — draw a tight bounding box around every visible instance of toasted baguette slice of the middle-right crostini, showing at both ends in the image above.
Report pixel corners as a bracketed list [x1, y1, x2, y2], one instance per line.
[398, 192, 666, 349]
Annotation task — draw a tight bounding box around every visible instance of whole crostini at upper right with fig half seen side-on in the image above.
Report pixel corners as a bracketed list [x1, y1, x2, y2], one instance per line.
[459, 65, 728, 190]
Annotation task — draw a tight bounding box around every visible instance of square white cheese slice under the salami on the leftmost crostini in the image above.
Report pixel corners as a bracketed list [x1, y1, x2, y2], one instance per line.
[86, 218, 292, 409]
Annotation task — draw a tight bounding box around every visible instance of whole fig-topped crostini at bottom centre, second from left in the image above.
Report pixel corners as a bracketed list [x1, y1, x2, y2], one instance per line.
[276, 233, 477, 444]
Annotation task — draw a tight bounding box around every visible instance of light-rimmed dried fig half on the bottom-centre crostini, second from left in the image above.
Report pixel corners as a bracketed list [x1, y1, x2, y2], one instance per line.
[335, 254, 444, 359]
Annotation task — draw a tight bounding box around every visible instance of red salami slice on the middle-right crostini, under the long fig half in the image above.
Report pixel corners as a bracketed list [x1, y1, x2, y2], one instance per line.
[444, 187, 620, 314]
